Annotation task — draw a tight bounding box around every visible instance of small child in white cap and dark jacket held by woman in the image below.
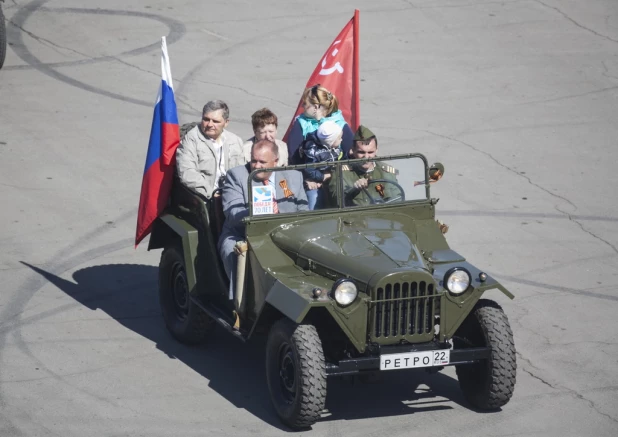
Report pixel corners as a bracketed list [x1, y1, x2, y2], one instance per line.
[300, 121, 343, 209]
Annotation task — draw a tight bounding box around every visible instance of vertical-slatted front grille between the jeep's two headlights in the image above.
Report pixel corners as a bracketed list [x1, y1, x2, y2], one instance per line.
[370, 281, 440, 343]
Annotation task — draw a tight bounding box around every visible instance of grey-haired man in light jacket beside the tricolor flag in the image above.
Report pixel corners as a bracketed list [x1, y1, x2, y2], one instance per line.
[176, 100, 245, 198]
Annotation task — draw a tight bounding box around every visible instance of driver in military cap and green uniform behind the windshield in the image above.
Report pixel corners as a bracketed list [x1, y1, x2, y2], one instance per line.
[328, 125, 402, 206]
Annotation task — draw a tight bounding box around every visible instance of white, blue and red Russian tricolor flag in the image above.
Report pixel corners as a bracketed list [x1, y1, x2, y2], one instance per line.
[135, 37, 180, 247]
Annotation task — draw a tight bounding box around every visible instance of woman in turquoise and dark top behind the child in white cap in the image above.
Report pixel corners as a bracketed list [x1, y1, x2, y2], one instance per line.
[288, 84, 354, 165]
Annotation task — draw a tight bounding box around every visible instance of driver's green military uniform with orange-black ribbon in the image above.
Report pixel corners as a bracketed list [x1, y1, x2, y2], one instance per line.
[328, 161, 401, 206]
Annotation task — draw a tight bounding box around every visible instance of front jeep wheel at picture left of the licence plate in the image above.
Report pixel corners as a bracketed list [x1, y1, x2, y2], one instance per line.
[266, 319, 326, 430]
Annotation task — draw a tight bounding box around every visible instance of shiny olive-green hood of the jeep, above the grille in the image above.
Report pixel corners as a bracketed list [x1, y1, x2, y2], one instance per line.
[271, 215, 426, 283]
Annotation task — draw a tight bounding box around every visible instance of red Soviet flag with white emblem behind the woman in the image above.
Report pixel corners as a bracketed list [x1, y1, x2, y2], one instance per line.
[283, 9, 360, 141]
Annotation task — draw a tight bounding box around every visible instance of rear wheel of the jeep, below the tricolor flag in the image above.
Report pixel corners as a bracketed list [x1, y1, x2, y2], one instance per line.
[159, 246, 215, 344]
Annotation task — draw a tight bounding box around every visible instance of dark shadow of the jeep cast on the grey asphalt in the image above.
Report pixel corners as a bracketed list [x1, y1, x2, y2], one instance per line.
[22, 262, 476, 430]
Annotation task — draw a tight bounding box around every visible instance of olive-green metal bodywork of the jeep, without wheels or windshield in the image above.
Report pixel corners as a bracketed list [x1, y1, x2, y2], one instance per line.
[149, 155, 513, 355]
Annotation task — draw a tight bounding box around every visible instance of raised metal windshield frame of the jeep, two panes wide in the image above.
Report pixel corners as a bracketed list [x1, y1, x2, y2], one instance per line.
[247, 153, 431, 216]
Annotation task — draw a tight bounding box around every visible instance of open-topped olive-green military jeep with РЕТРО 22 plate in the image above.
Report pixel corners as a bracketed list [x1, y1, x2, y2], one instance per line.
[149, 154, 516, 429]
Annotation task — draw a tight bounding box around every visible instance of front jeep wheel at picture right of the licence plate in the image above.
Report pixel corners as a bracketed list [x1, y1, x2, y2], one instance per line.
[453, 299, 517, 410]
